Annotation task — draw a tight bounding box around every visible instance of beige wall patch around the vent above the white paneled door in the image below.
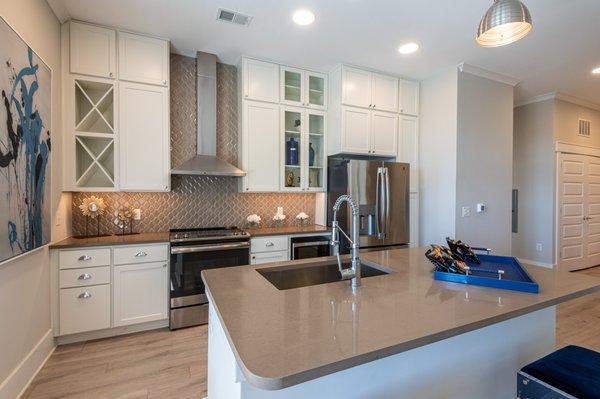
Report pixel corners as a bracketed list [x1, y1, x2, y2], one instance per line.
[554, 100, 600, 148]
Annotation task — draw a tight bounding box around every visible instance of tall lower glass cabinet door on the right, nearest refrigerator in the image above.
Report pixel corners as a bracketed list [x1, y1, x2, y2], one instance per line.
[305, 111, 327, 191]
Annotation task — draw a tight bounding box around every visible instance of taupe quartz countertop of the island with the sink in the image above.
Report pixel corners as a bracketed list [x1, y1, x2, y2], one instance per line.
[202, 248, 600, 389]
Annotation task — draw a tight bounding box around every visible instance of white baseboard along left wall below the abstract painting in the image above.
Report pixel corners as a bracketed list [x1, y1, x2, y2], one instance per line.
[0, 329, 56, 399]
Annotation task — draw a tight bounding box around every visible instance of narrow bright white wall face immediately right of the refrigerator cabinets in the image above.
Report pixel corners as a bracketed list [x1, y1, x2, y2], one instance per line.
[419, 67, 458, 245]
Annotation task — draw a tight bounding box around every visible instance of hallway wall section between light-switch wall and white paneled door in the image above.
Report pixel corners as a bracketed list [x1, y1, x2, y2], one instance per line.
[512, 99, 556, 265]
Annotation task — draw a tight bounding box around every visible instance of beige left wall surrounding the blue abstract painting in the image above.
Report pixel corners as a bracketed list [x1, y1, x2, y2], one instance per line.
[0, 0, 71, 397]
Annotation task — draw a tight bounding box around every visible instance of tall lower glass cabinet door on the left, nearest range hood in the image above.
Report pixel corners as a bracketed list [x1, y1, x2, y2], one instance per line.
[280, 107, 305, 191]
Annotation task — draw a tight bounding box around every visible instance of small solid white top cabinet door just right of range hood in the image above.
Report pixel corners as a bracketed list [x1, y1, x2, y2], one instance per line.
[242, 58, 279, 103]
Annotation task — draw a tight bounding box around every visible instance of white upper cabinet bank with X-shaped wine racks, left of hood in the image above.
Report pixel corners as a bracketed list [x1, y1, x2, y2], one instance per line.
[62, 21, 170, 191]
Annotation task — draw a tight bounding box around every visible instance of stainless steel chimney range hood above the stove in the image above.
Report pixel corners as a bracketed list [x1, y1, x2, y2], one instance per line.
[171, 51, 246, 177]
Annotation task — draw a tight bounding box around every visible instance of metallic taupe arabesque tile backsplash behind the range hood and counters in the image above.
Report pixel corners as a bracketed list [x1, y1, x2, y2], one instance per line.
[72, 54, 315, 235]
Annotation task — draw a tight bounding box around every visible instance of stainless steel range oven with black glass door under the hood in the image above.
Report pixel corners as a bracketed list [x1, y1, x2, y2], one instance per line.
[169, 227, 250, 330]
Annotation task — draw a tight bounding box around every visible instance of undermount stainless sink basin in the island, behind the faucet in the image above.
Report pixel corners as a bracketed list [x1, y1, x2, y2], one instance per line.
[256, 262, 389, 290]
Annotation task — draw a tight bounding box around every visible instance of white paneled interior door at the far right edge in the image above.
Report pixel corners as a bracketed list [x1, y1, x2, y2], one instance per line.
[558, 154, 600, 270]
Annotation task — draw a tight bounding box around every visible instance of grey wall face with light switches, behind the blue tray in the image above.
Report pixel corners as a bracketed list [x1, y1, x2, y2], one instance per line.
[455, 72, 513, 255]
